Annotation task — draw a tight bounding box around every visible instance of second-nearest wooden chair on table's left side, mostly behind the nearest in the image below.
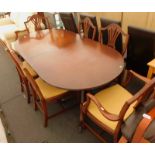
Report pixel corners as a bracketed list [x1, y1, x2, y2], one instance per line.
[9, 50, 38, 103]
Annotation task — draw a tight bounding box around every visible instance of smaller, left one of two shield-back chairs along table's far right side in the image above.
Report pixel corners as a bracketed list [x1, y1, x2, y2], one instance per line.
[79, 17, 96, 40]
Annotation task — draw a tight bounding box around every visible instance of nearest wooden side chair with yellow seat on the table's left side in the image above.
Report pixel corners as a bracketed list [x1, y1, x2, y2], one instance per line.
[24, 69, 68, 127]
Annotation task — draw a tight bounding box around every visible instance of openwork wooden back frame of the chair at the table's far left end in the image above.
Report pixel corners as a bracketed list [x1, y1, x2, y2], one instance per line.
[24, 14, 51, 32]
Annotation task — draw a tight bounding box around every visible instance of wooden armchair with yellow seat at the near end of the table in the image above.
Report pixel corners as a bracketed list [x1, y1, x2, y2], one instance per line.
[80, 71, 155, 142]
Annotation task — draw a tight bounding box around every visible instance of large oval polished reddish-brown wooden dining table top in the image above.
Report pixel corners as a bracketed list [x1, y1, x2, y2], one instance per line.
[12, 29, 124, 100]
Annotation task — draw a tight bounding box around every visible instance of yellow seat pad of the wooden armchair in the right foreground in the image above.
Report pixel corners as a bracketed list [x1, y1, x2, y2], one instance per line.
[88, 84, 136, 131]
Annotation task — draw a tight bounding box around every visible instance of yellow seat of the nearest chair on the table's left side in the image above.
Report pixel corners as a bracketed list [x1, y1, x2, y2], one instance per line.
[35, 78, 67, 100]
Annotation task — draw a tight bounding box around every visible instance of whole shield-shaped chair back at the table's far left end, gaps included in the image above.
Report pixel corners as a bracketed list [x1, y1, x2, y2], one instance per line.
[24, 14, 51, 32]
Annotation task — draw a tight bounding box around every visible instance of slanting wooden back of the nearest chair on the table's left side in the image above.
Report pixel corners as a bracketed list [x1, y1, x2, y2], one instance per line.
[24, 68, 44, 101]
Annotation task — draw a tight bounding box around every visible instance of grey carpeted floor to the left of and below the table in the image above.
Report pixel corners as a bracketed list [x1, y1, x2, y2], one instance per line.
[0, 49, 99, 143]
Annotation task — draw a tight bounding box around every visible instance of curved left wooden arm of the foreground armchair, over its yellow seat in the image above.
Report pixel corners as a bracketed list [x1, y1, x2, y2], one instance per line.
[87, 93, 120, 121]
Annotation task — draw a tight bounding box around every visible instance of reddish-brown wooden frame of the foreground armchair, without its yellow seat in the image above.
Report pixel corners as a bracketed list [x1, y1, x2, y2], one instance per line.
[80, 71, 155, 142]
